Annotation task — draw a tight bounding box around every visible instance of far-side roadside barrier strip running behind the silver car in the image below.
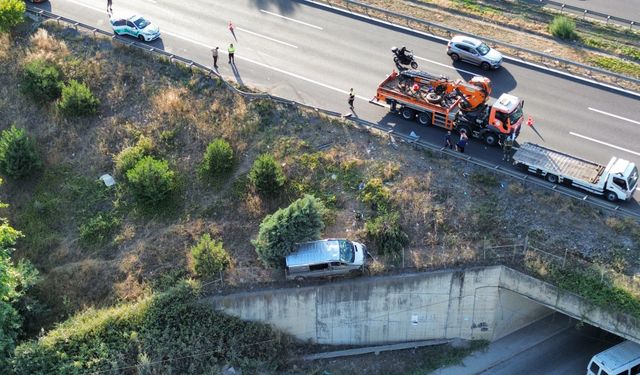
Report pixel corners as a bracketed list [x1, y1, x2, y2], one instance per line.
[302, 0, 640, 90]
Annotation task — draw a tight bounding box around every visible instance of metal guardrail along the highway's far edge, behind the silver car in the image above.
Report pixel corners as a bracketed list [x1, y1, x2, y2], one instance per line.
[300, 0, 640, 89]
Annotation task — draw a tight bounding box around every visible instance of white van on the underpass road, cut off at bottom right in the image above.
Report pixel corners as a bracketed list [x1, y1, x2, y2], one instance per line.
[587, 341, 640, 375]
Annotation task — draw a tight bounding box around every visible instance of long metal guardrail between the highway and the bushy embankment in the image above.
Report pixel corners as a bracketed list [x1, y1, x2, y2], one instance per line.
[27, 8, 640, 220]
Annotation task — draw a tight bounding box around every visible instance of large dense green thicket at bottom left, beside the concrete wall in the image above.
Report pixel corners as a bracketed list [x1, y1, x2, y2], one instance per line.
[13, 282, 291, 375]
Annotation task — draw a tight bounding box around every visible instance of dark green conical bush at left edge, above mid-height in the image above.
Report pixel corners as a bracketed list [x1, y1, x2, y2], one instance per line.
[0, 125, 40, 178]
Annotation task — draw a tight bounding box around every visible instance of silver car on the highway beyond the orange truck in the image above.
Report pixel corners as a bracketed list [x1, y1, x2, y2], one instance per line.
[447, 35, 502, 70]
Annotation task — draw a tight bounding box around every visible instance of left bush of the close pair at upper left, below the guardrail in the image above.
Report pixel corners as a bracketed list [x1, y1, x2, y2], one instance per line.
[21, 59, 62, 102]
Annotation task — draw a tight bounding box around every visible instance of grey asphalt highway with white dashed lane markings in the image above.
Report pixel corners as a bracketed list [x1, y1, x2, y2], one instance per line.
[32, 0, 640, 209]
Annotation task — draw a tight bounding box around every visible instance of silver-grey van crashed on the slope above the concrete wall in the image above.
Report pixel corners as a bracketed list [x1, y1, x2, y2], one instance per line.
[286, 238, 367, 280]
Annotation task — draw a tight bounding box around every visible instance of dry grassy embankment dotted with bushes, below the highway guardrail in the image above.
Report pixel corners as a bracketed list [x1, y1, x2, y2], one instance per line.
[0, 8, 640, 374]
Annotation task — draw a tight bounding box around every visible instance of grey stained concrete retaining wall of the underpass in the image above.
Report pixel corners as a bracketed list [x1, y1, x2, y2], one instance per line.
[206, 266, 638, 345]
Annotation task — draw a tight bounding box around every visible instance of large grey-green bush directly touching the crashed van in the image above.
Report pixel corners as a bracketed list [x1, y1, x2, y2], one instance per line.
[252, 195, 325, 267]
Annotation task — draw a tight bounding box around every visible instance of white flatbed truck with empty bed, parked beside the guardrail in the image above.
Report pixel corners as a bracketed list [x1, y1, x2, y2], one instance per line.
[513, 143, 638, 201]
